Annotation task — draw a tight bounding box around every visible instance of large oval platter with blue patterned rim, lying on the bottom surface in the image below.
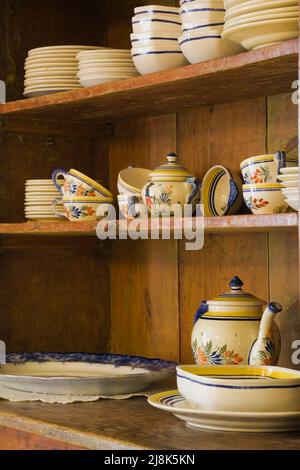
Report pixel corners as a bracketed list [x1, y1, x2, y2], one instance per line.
[0, 353, 175, 403]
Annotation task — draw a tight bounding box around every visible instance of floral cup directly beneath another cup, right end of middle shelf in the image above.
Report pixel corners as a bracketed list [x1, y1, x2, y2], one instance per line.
[243, 183, 288, 215]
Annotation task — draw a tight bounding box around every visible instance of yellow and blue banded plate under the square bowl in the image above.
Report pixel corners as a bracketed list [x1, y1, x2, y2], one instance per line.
[148, 390, 300, 432]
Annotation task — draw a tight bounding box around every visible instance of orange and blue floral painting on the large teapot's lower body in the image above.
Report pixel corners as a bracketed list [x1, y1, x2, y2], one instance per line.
[193, 341, 244, 366]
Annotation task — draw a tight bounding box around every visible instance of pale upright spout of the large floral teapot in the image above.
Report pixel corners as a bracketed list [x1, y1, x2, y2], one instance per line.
[249, 302, 282, 366]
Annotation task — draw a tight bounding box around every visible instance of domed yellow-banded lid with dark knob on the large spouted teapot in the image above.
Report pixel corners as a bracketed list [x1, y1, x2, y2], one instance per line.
[207, 276, 267, 308]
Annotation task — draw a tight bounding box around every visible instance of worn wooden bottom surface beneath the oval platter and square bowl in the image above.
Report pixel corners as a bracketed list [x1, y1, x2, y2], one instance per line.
[0, 396, 300, 451]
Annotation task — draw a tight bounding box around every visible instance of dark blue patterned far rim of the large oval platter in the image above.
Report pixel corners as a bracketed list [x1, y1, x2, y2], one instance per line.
[6, 352, 178, 372]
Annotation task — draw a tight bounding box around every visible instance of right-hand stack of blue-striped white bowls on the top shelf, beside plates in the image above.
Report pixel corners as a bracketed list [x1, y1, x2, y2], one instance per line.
[179, 0, 243, 64]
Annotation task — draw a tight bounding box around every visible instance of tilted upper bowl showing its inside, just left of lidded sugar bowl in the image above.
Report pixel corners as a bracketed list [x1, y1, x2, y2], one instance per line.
[118, 167, 151, 197]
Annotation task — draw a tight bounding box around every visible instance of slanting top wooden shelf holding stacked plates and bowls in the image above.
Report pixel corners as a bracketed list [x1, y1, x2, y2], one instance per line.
[0, 39, 298, 122]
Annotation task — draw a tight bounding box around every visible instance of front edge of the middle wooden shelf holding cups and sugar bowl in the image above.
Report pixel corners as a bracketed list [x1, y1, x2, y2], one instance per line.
[0, 213, 298, 236]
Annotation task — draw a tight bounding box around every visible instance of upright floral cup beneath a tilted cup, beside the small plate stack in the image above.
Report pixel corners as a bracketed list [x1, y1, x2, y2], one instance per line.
[52, 197, 113, 222]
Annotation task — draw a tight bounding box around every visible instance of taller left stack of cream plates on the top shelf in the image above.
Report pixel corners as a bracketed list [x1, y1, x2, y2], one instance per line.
[24, 46, 96, 97]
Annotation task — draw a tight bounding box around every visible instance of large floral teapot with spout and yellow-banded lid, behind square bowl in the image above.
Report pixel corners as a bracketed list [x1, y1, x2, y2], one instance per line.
[192, 276, 282, 366]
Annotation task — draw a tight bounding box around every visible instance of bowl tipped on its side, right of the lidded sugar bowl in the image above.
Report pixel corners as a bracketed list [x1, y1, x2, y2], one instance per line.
[201, 165, 243, 217]
